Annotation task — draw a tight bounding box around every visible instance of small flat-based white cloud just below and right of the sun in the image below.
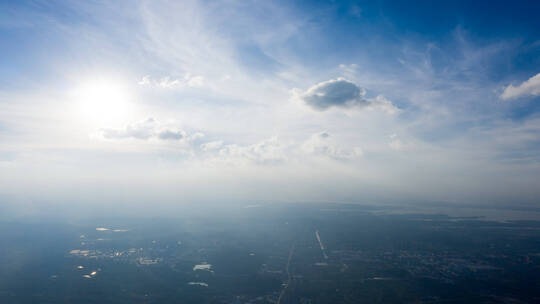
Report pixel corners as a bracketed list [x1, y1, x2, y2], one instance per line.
[99, 118, 186, 140]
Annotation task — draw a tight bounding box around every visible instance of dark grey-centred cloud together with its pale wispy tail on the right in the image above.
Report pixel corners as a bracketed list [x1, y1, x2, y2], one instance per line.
[296, 78, 399, 114]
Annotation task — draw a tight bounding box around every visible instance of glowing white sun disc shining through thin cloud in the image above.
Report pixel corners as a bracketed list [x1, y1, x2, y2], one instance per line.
[75, 79, 131, 126]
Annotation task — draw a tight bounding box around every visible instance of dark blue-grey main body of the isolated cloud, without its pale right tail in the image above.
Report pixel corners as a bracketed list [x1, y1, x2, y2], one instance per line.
[301, 78, 370, 111]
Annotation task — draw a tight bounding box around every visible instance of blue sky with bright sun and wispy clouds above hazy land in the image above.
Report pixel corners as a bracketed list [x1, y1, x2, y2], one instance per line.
[0, 0, 540, 212]
